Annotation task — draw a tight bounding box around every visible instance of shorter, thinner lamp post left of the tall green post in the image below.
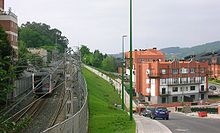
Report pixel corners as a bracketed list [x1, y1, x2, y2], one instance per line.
[121, 35, 127, 110]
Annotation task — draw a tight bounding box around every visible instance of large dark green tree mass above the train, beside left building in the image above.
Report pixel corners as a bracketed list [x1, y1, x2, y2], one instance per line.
[18, 22, 68, 53]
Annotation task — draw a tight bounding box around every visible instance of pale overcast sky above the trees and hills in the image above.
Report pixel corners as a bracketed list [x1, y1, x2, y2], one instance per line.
[5, 0, 220, 53]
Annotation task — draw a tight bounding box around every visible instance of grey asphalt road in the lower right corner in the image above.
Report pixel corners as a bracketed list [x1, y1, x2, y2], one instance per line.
[158, 113, 220, 133]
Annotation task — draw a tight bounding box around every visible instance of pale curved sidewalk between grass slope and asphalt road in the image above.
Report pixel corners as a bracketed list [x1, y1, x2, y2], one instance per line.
[133, 114, 172, 133]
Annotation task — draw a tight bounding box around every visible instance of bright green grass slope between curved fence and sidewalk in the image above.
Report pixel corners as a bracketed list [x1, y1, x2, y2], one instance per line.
[83, 68, 135, 133]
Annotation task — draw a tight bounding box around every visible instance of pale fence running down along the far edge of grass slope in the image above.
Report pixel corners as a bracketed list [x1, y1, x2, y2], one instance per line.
[85, 65, 137, 109]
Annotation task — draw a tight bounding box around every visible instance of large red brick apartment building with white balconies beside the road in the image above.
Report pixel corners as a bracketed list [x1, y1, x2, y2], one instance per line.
[126, 48, 208, 104]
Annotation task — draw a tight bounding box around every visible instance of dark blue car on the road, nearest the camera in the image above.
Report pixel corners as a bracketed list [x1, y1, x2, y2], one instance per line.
[150, 107, 170, 120]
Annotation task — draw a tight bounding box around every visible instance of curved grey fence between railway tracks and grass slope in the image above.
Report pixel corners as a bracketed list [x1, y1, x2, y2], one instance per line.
[43, 70, 89, 133]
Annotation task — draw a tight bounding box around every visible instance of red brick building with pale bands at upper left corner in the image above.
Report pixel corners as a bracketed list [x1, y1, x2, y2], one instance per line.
[0, 0, 18, 53]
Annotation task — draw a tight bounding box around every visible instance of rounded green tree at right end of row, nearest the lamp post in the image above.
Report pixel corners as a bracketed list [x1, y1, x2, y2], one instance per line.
[102, 56, 117, 72]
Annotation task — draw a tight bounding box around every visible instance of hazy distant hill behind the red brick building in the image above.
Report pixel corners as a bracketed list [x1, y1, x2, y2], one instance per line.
[161, 41, 220, 58]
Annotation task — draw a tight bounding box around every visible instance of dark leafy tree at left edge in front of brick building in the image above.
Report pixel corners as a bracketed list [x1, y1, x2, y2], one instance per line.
[0, 27, 15, 102]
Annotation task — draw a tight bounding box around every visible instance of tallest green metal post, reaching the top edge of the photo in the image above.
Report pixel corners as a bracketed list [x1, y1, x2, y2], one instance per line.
[130, 0, 133, 120]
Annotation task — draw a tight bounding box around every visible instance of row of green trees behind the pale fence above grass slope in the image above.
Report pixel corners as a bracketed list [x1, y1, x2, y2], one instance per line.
[80, 45, 117, 72]
